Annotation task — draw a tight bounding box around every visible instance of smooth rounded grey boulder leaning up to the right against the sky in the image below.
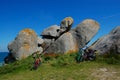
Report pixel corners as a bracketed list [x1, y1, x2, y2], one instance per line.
[75, 19, 99, 45]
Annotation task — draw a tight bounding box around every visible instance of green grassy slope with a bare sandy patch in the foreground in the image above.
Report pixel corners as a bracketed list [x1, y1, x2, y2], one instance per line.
[0, 54, 120, 80]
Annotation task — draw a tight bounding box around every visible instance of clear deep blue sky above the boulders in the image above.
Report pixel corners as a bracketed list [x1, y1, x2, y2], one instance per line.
[0, 0, 120, 52]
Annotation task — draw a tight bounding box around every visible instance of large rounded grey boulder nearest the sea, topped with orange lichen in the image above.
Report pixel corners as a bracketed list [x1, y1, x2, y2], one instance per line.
[8, 29, 42, 60]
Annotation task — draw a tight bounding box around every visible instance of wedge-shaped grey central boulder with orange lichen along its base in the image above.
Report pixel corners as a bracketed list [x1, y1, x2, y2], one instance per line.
[45, 32, 78, 54]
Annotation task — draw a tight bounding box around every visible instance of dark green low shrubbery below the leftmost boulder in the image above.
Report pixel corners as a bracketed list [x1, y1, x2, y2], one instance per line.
[0, 57, 33, 74]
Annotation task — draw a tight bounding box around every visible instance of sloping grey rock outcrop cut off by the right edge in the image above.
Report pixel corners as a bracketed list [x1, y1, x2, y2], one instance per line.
[90, 26, 120, 54]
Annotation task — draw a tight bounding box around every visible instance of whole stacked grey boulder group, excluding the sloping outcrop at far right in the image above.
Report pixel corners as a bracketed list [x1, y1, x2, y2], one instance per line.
[6, 17, 99, 60]
